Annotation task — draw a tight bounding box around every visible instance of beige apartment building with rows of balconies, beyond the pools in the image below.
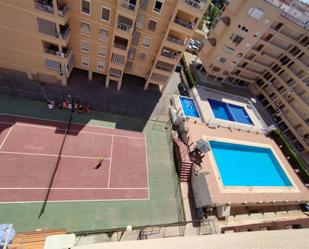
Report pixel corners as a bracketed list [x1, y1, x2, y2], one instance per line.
[198, 0, 309, 158]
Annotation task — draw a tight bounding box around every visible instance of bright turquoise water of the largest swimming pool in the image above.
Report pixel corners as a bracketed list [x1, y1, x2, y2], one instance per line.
[209, 141, 292, 187]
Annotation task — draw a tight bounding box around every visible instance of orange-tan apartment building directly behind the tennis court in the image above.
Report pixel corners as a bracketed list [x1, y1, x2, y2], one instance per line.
[0, 0, 208, 90]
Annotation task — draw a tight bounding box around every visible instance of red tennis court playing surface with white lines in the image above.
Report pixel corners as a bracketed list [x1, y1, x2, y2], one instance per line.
[0, 115, 149, 203]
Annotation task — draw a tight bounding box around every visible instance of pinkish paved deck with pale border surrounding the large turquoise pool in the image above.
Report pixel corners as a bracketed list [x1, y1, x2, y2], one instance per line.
[185, 120, 309, 207]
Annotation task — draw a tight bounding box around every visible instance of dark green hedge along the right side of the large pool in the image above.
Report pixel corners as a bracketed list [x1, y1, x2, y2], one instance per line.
[269, 129, 309, 183]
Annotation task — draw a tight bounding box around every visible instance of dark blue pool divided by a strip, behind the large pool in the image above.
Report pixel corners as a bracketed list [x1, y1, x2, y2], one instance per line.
[208, 99, 253, 125]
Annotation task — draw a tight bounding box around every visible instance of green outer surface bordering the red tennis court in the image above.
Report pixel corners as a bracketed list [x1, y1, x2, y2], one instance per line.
[0, 96, 184, 232]
